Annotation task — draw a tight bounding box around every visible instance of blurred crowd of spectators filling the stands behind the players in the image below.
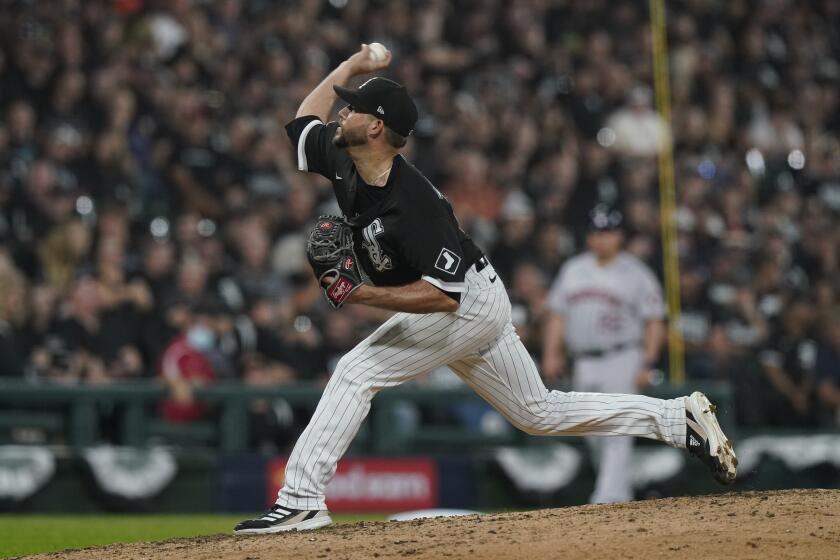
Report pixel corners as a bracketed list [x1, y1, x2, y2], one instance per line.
[0, 0, 840, 434]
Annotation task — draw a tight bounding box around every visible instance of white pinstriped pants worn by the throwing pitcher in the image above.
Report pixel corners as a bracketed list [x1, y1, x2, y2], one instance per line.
[277, 266, 685, 510]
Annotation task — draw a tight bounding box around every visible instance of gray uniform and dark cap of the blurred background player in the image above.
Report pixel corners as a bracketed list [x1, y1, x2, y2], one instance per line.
[548, 210, 665, 503]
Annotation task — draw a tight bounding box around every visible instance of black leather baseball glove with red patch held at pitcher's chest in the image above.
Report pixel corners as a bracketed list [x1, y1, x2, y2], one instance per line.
[306, 216, 363, 309]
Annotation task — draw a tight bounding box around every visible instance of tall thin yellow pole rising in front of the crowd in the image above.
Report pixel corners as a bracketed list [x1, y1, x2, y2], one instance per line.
[650, 0, 685, 384]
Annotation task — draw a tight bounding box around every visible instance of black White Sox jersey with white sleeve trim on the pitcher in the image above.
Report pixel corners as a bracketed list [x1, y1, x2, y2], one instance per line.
[286, 116, 481, 299]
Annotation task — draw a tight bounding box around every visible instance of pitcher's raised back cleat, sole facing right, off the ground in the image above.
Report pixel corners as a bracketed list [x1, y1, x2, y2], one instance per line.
[685, 391, 738, 484]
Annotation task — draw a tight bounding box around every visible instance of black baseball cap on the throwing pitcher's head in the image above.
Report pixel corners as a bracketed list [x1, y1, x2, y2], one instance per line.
[333, 77, 417, 136]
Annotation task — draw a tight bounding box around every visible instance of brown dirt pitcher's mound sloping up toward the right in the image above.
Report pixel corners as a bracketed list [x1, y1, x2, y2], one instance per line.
[18, 490, 840, 560]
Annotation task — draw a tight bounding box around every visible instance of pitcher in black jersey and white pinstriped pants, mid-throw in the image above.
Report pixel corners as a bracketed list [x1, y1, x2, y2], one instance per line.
[235, 46, 736, 534]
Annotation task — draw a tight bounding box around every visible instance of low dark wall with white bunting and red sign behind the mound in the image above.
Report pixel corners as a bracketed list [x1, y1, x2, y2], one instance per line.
[0, 434, 840, 513]
